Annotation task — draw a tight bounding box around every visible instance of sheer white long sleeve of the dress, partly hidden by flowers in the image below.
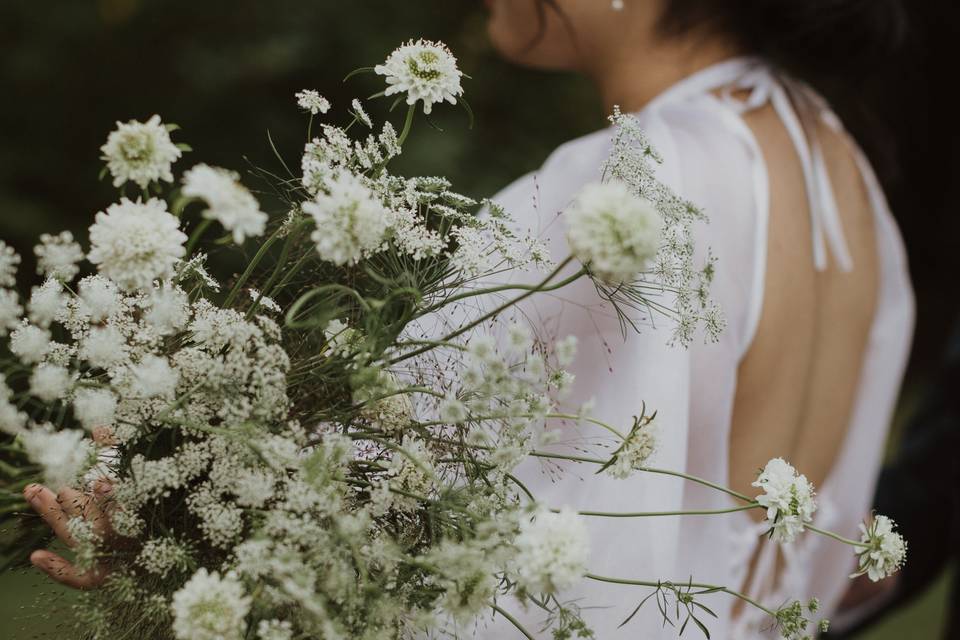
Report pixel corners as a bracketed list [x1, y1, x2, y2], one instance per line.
[478, 99, 762, 638]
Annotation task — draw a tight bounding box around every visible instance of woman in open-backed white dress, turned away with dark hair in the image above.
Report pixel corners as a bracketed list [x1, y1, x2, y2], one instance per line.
[478, 0, 914, 640]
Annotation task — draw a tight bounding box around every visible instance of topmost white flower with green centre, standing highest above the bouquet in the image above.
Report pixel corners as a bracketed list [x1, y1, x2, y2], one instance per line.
[374, 40, 463, 114]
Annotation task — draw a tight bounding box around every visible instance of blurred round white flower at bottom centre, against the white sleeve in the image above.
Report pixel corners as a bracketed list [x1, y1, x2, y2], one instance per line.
[516, 507, 590, 593]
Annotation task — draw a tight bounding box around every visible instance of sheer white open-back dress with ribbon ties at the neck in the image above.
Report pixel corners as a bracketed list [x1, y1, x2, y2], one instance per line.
[476, 58, 914, 640]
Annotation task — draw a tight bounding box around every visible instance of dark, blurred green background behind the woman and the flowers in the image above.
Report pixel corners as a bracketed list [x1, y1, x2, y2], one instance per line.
[0, 0, 960, 640]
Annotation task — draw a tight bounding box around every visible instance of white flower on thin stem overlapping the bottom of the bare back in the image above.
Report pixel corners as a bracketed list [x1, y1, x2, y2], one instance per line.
[753, 458, 817, 542]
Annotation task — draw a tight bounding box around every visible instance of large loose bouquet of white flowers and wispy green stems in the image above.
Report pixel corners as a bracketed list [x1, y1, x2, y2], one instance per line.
[0, 40, 904, 640]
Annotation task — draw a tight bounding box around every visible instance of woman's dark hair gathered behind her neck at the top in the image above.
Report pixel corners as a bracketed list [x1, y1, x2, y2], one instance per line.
[537, 0, 909, 187]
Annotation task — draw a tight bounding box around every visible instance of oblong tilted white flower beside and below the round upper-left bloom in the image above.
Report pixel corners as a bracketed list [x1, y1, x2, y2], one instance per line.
[183, 164, 267, 244]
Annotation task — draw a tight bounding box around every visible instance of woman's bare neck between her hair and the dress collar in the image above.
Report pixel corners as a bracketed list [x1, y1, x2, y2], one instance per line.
[587, 38, 741, 113]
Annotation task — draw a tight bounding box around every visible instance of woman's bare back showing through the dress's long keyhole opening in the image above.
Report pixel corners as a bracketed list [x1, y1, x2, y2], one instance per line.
[730, 99, 879, 504]
